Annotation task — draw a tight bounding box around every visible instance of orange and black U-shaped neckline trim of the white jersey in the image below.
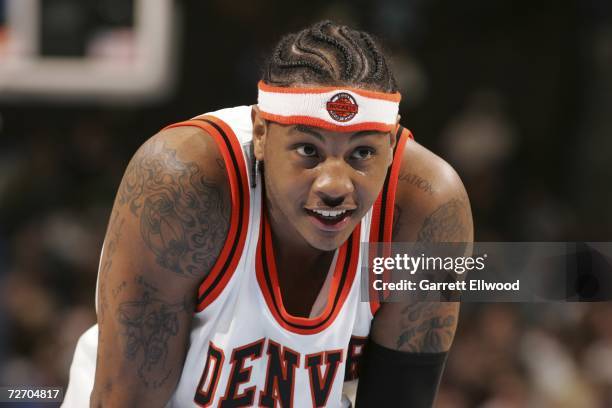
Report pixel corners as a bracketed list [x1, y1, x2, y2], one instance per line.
[255, 205, 361, 334]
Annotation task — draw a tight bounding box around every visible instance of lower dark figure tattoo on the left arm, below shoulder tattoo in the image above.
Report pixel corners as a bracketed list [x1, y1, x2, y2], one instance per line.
[116, 276, 192, 388]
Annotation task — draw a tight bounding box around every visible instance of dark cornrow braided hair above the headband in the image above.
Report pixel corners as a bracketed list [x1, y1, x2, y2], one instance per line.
[263, 21, 397, 92]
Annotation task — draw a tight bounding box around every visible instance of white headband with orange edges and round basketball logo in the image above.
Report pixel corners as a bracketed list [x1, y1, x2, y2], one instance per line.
[257, 81, 401, 132]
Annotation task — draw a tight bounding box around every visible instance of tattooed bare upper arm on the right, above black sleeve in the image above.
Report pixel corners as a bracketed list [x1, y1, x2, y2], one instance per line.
[371, 141, 474, 352]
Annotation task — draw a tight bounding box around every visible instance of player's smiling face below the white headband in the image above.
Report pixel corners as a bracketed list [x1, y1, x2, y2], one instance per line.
[253, 109, 395, 251]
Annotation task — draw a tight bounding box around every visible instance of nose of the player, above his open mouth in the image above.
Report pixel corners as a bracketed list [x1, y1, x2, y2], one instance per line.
[313, 159, 355, 207]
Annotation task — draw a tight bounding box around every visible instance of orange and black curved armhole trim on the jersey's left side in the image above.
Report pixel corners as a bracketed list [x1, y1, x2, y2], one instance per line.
[166, 116, 250, 312]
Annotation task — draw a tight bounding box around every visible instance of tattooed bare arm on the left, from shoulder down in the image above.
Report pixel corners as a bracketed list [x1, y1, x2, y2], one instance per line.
[92, 127, 231, 406]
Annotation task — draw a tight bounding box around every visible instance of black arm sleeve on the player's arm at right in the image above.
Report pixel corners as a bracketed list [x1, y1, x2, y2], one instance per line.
[355, 340, 448, 408]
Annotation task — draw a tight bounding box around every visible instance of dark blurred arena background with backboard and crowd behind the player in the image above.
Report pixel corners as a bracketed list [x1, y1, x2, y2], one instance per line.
[0, 0, 612, 408]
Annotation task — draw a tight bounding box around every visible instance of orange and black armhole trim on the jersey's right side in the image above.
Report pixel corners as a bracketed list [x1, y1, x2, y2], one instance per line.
[368, 126, 414, 315]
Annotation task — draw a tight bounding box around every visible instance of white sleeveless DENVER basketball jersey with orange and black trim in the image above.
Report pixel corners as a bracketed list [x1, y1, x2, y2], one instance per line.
[64, 106, 411, 407]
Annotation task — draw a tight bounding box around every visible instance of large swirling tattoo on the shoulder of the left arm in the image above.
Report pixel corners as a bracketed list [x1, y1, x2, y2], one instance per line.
[117, 141, 230, 276]
